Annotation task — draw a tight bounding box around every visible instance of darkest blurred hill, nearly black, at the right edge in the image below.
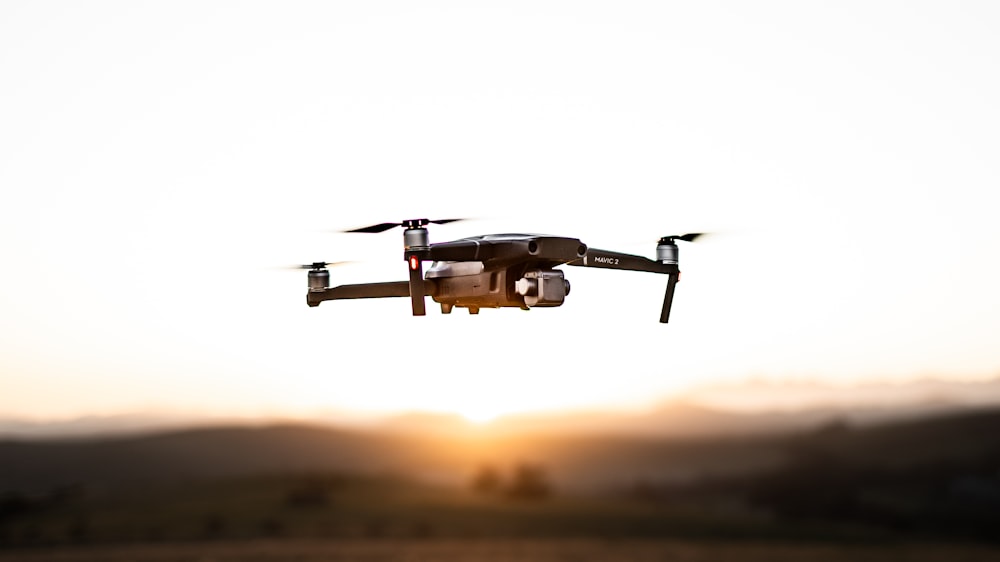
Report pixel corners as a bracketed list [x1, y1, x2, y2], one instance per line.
[660, 404, 1000, 543]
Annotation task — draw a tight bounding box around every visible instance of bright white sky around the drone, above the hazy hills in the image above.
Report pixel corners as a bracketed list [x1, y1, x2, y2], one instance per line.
[0, 1, 1000, 418]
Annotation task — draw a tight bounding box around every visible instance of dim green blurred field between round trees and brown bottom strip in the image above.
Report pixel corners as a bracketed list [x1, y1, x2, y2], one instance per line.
[0, 474, 792, 547]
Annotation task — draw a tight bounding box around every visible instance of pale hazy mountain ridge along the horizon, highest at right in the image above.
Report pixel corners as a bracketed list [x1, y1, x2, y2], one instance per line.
[0, 378, 1000, 440]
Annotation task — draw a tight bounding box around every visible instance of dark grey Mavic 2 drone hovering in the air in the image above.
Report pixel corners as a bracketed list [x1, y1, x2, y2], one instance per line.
[296, 219, 704, 324]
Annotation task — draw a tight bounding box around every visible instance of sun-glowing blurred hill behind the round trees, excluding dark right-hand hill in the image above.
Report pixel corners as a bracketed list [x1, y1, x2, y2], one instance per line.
[0, 416, 784, 490]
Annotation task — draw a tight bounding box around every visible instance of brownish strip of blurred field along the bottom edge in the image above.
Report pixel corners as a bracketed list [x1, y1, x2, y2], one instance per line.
[0, 540, 1000, 562]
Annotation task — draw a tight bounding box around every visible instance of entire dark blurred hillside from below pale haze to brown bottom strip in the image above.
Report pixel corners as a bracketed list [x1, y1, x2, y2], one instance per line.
[0, 409, 1000, 544]
